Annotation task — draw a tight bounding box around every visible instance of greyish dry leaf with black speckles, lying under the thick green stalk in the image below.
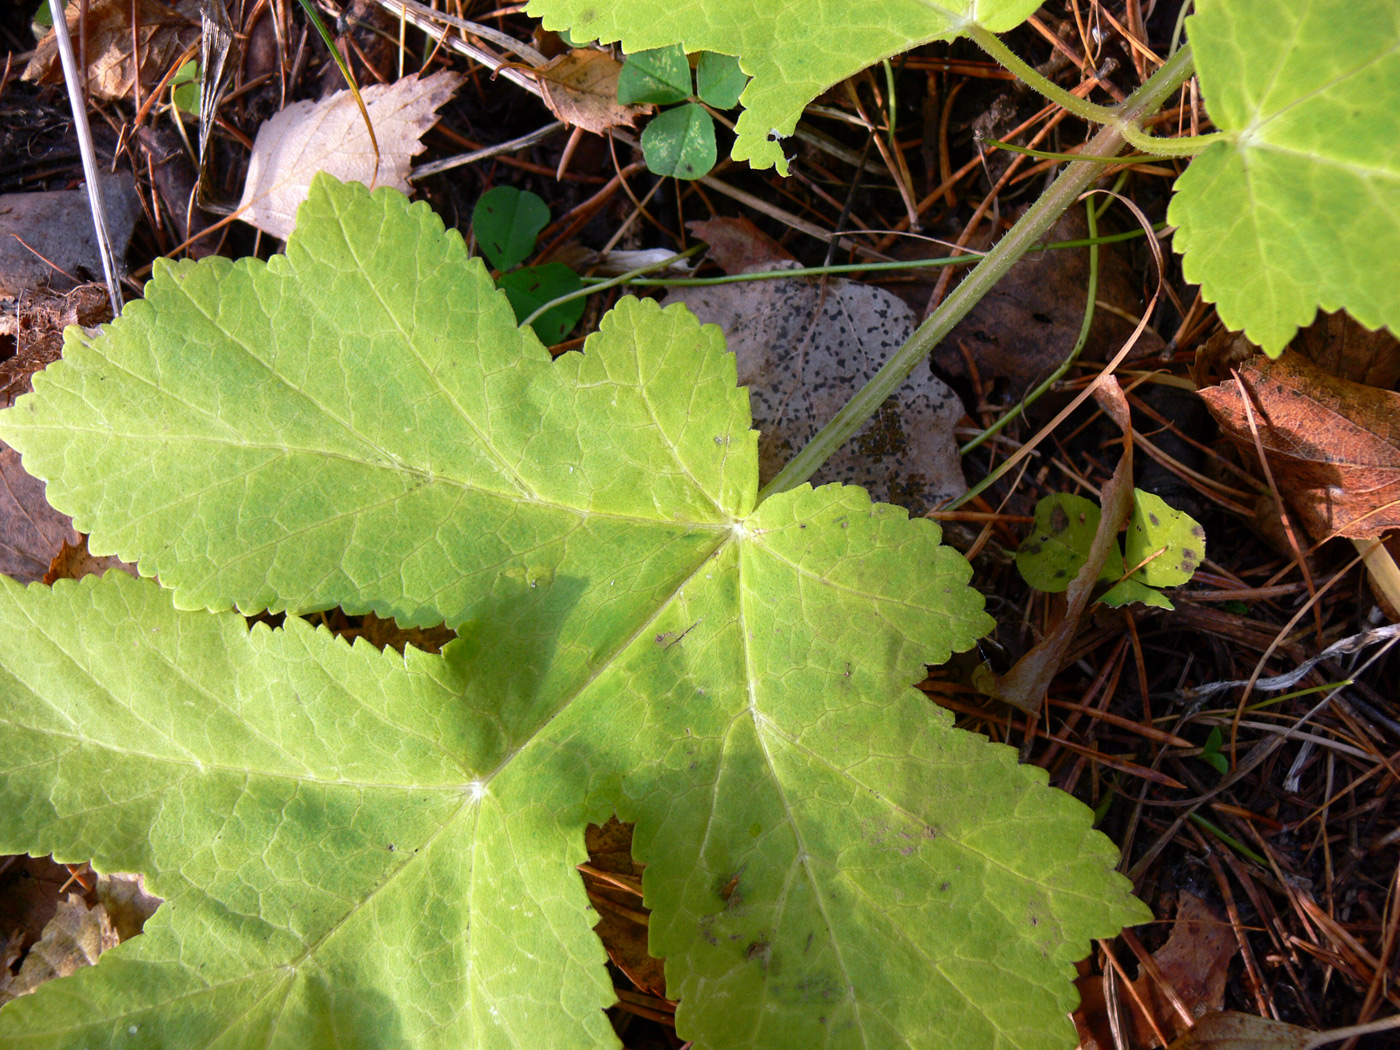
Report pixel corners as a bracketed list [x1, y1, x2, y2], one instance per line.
[665, 266, 967, 514]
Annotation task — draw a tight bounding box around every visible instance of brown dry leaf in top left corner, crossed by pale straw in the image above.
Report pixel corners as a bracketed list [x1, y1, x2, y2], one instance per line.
[24, 0, 200, 98]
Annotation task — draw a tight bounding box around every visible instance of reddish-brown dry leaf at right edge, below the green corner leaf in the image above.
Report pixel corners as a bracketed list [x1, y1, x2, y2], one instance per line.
[1200, 350, 1400, 540]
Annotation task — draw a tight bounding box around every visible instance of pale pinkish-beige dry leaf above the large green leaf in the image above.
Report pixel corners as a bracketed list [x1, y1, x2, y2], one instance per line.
[238, 71, 462, 239]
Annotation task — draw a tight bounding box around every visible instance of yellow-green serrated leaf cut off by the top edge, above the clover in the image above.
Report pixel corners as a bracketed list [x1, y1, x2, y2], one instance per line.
[526, 0, 1039, 175]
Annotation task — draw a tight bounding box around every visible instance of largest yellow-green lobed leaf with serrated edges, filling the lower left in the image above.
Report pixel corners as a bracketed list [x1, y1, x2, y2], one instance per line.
[0, 178, 1147, 1050]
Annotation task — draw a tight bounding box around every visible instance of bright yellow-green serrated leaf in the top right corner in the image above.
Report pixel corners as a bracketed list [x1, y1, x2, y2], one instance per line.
[1168, 0, 1400, 357]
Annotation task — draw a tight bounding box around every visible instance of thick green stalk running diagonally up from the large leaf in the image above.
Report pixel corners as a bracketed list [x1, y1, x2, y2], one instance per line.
[759, 48, 1194, 498]
